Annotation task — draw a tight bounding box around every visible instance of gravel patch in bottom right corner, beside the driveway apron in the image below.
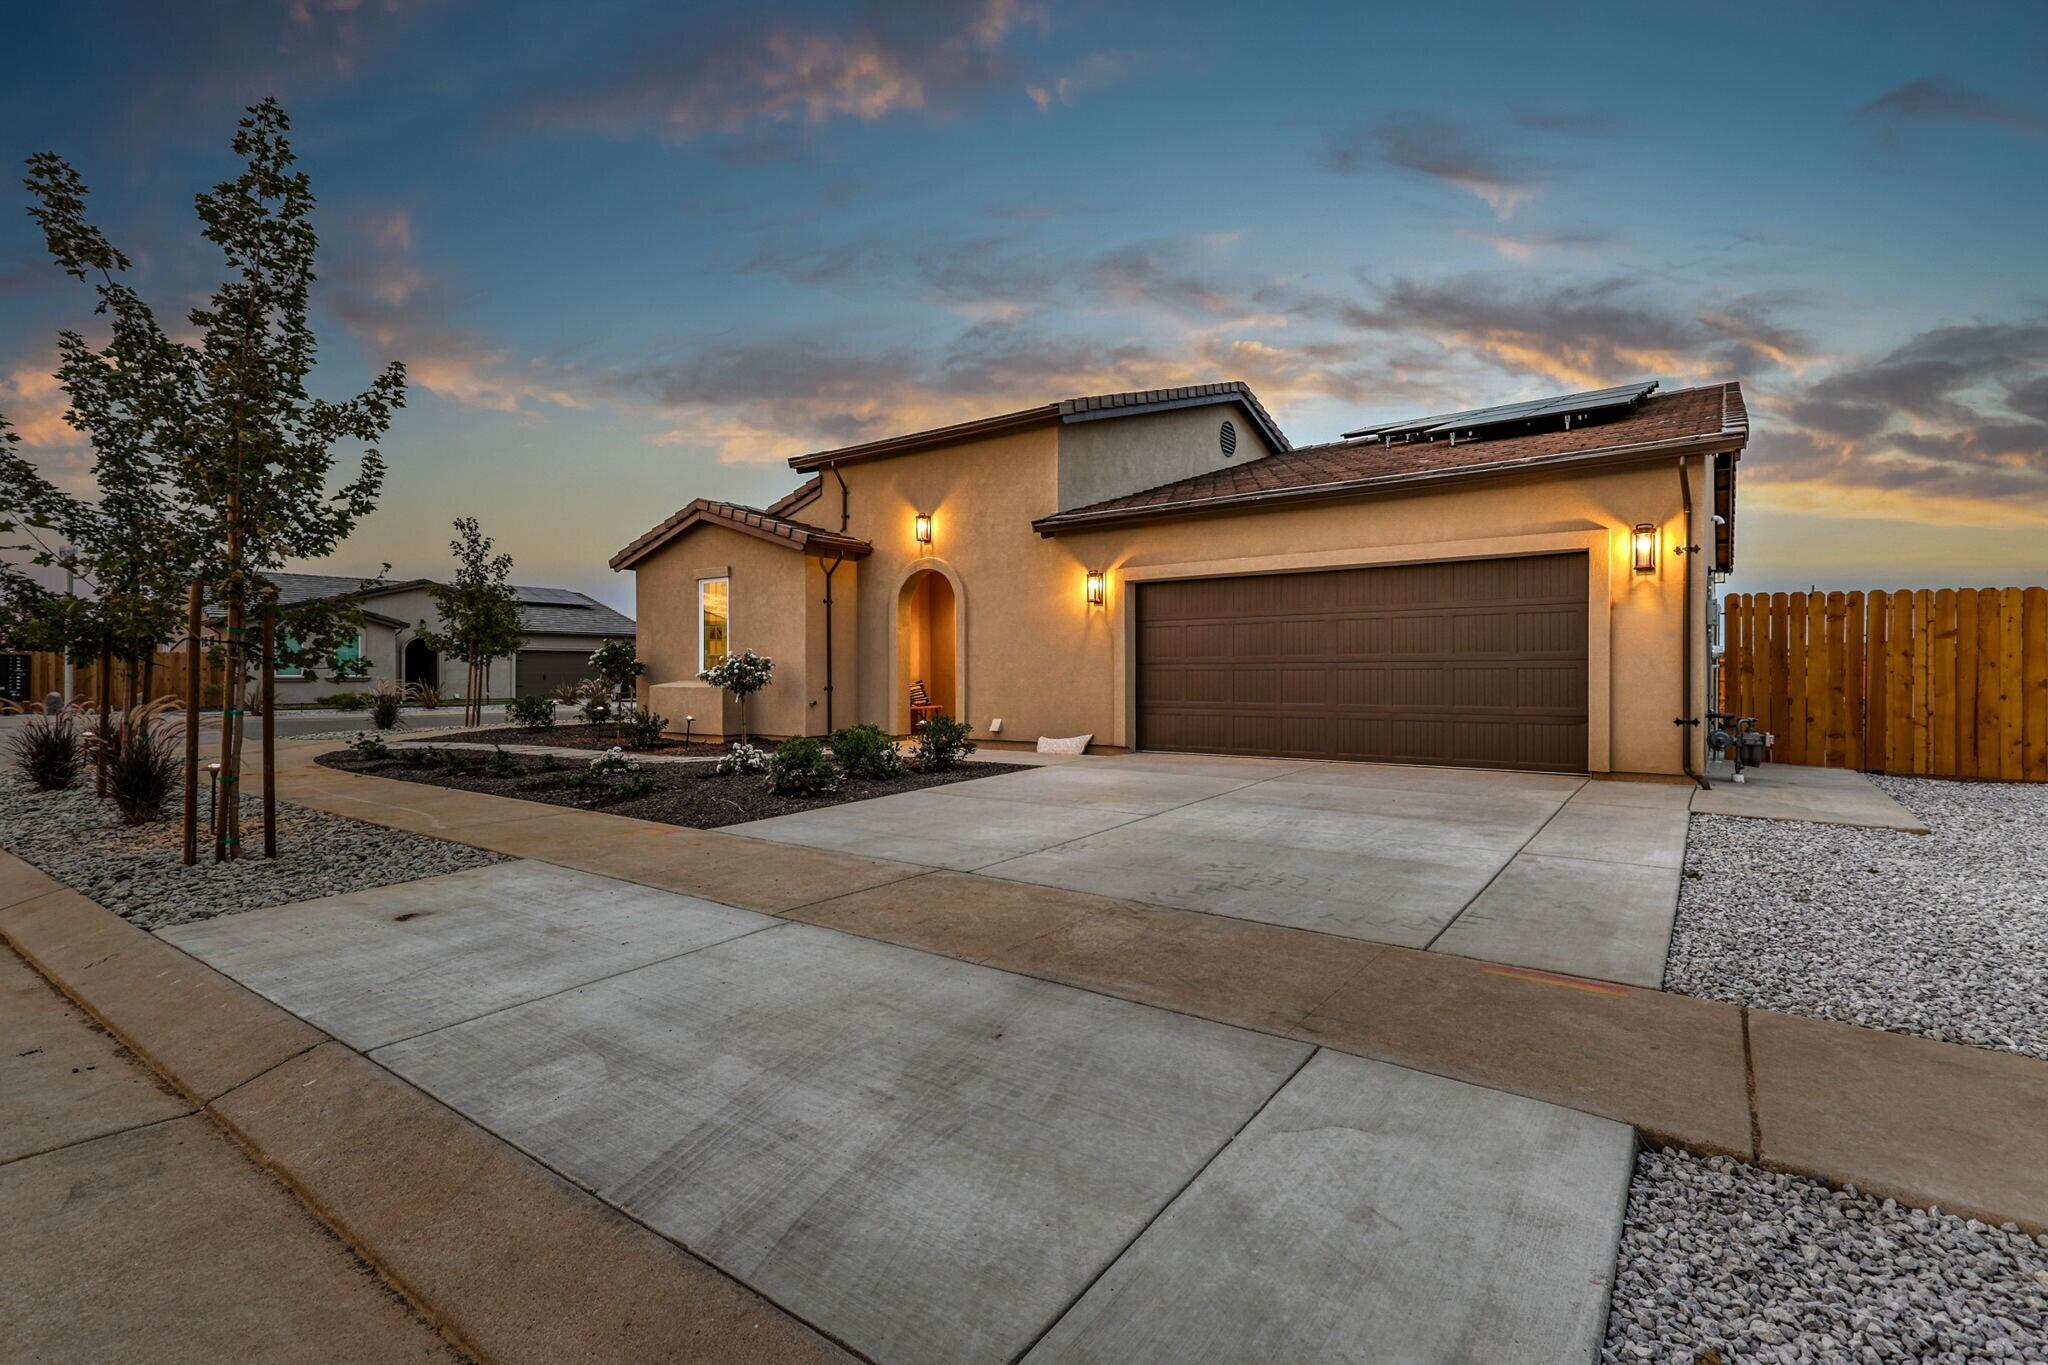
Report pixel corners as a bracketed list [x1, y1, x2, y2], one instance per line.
[1602, 1148, 2048, 1365]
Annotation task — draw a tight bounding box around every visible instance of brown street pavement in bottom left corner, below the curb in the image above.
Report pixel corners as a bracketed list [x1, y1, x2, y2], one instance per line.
[0, 950, 469, 1363]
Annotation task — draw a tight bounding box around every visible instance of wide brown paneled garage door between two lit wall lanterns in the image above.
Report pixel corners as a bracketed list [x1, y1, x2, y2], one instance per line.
[1139, 555, 1587, 772]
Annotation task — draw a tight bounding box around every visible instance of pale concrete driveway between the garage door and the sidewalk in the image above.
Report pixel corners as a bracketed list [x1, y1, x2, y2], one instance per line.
[727, 753, 1692, 986]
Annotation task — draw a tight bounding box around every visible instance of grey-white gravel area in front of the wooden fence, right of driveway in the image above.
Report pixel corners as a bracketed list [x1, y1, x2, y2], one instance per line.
[1665, 778, 2048, 1058]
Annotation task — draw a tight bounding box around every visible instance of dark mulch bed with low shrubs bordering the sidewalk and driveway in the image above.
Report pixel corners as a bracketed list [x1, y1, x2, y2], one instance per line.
[313, 753, 1028, 829]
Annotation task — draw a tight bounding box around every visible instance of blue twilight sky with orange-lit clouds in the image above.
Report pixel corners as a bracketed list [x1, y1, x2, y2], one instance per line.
[0, 0, 2048, 610]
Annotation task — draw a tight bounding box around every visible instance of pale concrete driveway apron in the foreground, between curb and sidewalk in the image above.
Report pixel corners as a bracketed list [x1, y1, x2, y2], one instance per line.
[162, 863, 1632, 1363]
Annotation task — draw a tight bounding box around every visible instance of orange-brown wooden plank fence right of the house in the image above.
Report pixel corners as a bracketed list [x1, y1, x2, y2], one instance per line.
[1720, 587, 2048, 782]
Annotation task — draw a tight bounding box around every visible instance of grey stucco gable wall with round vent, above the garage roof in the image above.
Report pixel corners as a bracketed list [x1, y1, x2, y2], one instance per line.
[1059, 403, 1272, 512]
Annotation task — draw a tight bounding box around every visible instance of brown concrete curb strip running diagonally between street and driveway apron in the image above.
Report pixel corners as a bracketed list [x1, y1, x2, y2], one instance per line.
[0, 851, 854, 1365]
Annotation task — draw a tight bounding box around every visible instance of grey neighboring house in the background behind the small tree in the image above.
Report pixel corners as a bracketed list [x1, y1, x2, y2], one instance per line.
[209, 573, 633, 702]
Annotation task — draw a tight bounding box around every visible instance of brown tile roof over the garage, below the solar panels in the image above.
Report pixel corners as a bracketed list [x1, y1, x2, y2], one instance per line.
[1032, 383, 1749, 534]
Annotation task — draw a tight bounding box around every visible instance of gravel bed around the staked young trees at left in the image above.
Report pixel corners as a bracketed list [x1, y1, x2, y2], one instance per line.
[0, 772, 500, 929]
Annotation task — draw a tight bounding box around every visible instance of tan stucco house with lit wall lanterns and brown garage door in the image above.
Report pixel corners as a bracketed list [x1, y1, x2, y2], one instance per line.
[612, 383, 1749, 774]
